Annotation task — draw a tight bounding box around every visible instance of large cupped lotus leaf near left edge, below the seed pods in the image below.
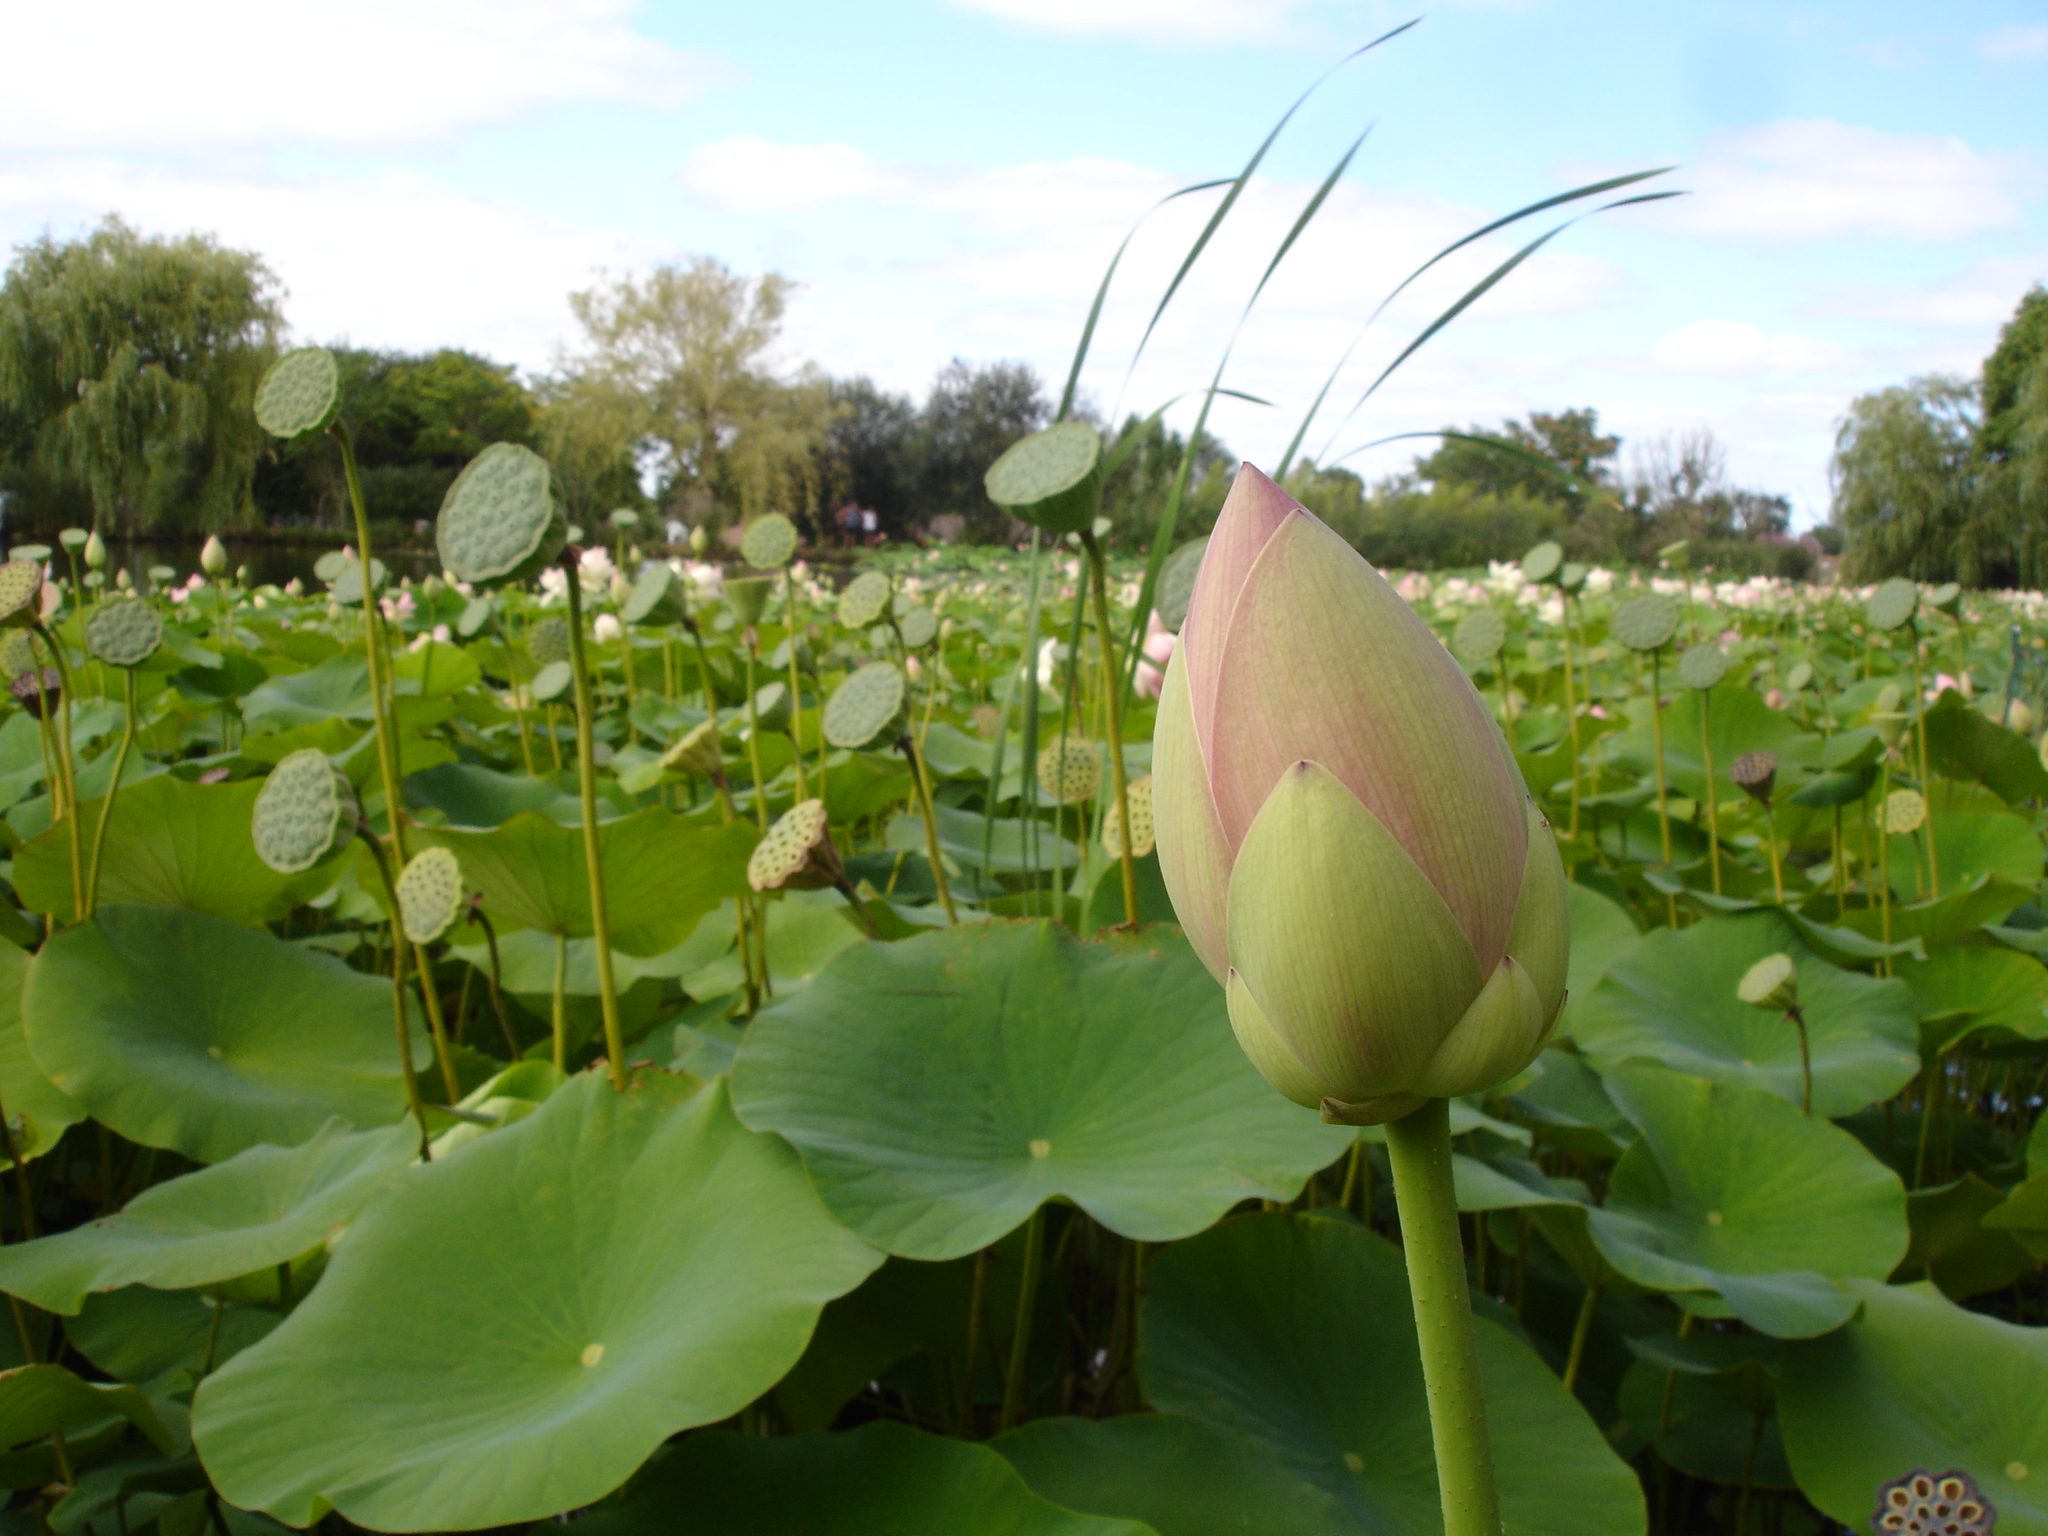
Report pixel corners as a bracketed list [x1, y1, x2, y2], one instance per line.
[20, 907, 424, 1163]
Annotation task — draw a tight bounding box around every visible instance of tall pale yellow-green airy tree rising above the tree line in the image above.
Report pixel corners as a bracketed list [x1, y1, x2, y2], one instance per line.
[565, 256, 831, 522]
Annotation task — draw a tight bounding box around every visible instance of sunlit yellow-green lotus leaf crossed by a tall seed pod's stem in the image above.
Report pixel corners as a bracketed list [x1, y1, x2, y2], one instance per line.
[418, 805, 758, 954]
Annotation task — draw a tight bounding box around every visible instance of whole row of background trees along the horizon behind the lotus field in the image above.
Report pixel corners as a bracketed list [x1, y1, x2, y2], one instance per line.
[0, 217, 2048, 586]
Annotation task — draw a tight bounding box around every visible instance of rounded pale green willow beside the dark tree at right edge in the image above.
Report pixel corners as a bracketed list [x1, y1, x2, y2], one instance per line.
[1833, 375, 1982, 586]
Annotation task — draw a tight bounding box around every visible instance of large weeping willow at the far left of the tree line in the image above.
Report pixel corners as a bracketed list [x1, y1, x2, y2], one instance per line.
[0, 217, 281, 532]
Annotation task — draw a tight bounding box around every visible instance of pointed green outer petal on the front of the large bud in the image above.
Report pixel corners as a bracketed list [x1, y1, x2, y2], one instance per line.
[1229, 762, 1483, 1102]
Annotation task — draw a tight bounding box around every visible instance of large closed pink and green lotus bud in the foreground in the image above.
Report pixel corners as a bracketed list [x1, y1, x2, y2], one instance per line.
[1153, 465, 1571, 1124]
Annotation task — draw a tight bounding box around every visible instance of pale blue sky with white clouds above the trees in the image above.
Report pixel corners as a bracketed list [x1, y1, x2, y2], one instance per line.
[0, 0, 2048, 526]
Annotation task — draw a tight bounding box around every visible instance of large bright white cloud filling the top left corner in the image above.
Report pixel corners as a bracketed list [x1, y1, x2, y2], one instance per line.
[0, 0, 719, 154]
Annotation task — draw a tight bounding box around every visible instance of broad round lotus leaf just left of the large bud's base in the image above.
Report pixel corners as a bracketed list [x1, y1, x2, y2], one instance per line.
[733, 922, 1354, 1260]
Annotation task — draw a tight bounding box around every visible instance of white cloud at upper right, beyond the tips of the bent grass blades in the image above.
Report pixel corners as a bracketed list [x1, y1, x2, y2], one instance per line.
[1663, 119, 2021, 240]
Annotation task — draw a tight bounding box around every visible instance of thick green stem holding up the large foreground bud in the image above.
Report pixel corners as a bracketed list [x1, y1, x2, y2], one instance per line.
[1386, 1098, 1501, 1536]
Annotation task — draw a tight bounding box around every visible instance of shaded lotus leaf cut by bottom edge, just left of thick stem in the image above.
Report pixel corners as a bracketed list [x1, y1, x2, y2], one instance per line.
[991, 1413, 1358, 1536]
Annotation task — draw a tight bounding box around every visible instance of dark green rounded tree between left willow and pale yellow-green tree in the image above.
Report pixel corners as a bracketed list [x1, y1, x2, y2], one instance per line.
[256, 346, 539, 526]
